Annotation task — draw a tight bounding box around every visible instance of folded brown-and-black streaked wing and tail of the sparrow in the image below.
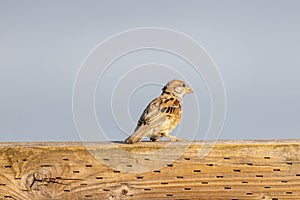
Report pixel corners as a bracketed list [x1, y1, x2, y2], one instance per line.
[125, 96, 181, 143]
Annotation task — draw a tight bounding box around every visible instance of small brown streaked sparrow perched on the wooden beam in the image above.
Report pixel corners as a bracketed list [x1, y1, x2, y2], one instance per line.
[125, 79, 193, 144]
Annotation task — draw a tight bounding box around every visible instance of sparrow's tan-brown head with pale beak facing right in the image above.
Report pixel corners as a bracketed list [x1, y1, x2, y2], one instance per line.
[162, 80, 193, 98]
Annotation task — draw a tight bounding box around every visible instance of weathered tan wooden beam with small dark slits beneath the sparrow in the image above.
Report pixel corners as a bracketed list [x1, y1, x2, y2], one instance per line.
[0, 140, 300, 200]
